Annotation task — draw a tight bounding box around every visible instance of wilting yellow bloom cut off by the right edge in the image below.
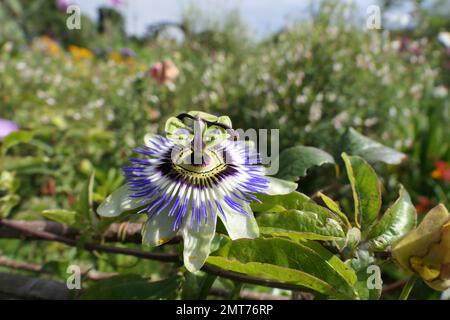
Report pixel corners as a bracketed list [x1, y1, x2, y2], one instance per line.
[392, 205, 450, 291]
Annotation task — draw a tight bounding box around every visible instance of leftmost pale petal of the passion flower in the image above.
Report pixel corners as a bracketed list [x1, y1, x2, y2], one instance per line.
[97, 184, 143, 217]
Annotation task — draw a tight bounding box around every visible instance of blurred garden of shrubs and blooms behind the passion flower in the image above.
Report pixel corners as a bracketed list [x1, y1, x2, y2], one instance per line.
[0, 0, 450, 298]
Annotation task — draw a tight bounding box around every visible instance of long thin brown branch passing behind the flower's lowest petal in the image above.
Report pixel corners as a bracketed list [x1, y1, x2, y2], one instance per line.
[0, 219, 312, 291]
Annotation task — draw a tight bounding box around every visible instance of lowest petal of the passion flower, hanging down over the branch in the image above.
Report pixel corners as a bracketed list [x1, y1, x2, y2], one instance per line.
[181, 210, 217, 272]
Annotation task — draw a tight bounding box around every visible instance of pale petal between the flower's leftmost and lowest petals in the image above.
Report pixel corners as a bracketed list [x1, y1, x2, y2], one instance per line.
[141, 211, 177, 247]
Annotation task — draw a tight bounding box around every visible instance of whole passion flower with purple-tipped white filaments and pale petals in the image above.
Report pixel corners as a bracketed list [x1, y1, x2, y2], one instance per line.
[97, 111, 297, 272]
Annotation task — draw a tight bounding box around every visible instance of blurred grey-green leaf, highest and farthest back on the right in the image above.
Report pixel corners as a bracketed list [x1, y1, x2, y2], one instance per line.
[342, 128, 406, 164]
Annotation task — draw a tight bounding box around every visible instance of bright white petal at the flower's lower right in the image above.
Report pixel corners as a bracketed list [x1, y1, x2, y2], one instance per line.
[219, 202, 259, 240]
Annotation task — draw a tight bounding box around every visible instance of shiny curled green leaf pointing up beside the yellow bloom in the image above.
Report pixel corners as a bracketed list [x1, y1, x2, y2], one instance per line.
[366, 186, 417, 250]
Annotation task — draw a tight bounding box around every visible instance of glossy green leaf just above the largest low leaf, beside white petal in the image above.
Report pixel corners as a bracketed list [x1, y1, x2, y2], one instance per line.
[256, 209, 345, 240]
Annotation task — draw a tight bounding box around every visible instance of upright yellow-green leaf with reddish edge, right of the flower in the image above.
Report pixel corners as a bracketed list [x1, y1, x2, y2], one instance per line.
[342, 153, 381, 230]
